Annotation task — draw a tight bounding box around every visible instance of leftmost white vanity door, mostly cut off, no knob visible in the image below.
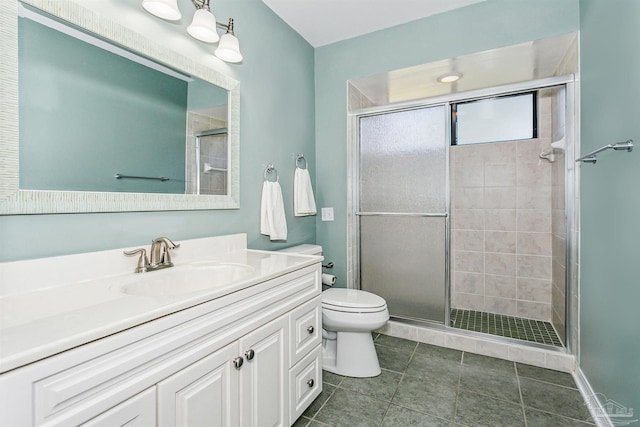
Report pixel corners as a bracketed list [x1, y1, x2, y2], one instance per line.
[82, 387, 156, 427]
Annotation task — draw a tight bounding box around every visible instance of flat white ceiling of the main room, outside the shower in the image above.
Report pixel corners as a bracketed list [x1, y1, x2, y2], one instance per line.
[262, 0, 484, 47]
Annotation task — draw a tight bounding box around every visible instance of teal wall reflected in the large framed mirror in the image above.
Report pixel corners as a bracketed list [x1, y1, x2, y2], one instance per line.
[19, 19, 187, 194]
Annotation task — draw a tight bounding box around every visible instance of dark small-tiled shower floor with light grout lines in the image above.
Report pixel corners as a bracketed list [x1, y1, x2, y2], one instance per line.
[451, 308, 562, 346]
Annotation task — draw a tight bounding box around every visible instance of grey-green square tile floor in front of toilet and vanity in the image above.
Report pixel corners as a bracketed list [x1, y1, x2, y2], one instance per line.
[294, 334, 594, 427]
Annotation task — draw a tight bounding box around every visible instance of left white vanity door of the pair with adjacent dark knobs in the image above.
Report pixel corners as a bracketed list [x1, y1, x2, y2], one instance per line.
[158, 342, 240, 427]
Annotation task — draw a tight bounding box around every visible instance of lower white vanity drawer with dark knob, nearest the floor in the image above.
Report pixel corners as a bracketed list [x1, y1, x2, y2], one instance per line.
[289, 345, 322, 421]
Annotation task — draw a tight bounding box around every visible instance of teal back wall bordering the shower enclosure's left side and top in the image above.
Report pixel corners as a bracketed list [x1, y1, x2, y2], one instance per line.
[315, 0, 579, 286]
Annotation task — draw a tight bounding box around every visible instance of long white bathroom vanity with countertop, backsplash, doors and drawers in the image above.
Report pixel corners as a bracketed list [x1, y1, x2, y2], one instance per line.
[0, 234, 322, 427]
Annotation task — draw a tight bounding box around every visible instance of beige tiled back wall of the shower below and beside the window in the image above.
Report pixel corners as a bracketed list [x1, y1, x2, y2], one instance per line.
[450, 93, 553, 321]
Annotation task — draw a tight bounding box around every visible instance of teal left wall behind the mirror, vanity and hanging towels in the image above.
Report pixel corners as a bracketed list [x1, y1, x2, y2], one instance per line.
[0, 0, 315, 261]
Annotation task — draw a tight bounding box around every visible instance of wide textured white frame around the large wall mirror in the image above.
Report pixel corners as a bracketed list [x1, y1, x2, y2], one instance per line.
[0, 0, 240, 215]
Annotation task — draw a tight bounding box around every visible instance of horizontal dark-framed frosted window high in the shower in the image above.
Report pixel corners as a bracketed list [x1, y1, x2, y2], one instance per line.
[451, 92, 537, 145]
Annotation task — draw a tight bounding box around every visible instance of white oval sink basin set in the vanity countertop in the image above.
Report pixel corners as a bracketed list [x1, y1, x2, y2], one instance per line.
[118, 263, 254, 296]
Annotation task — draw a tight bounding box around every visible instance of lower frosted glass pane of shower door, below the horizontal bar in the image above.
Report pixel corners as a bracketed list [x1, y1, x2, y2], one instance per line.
[360, 217, 445, 322]
